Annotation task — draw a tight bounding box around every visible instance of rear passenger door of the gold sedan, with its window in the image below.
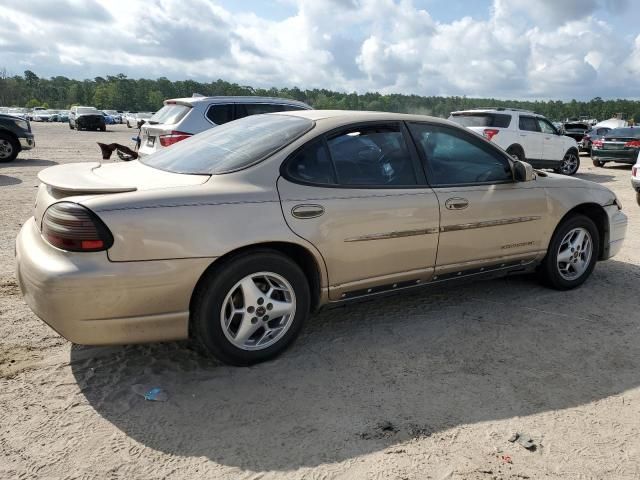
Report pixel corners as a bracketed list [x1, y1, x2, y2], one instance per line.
[278, 123, 440, 300]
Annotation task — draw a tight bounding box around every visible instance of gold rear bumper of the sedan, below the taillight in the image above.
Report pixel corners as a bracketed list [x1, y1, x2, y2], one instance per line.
[16, 218, 212, 345]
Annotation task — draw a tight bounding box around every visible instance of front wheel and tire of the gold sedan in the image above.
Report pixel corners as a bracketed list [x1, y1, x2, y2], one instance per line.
[539, 215, 600, 290]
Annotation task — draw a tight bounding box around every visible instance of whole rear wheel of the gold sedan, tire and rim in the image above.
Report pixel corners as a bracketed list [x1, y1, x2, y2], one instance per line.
[191, 250, 310, 366]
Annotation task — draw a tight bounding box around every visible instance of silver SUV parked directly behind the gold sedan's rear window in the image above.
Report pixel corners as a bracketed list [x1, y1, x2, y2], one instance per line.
[138, 97, 311, 155]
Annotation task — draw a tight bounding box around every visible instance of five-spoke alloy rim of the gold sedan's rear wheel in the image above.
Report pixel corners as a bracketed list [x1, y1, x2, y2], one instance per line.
[220, 272, 296, 350]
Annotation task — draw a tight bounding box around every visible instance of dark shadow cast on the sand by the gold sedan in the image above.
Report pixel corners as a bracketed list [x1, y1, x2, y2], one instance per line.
[71, 261, 640, 471]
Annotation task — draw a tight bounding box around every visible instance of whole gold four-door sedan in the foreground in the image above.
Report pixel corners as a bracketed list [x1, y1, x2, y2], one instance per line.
[16, 110, 627, 365]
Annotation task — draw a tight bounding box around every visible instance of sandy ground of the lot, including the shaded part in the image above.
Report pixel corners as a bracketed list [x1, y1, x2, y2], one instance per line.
[0, 124, 640, 480]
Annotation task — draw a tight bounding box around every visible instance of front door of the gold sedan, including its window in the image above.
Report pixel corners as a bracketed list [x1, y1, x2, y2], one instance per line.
[409, 123, 547, 279]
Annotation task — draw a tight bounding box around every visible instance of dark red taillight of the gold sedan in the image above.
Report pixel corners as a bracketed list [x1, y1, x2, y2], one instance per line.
[42, 202, 113, 252]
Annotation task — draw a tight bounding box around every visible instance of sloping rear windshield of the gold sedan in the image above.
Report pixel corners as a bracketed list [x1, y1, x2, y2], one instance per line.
[140, 114, 313, 175]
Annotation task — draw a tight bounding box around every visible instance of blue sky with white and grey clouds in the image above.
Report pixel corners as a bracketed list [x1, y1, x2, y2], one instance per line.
[0, 0, 640, 100]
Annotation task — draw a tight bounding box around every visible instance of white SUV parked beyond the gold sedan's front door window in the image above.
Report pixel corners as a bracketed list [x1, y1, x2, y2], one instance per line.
[449, 107, 580, 175]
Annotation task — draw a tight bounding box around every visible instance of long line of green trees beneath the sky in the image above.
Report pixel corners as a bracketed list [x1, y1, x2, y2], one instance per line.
[0, 69, 640, 122]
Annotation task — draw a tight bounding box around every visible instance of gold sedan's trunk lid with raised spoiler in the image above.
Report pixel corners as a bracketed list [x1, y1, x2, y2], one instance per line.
[34, 160, 210, 226]
